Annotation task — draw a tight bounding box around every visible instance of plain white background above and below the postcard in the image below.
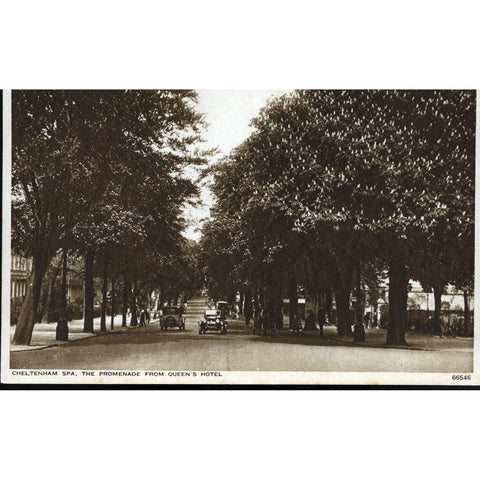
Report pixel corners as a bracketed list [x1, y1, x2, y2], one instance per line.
[0, 0, 480, 480]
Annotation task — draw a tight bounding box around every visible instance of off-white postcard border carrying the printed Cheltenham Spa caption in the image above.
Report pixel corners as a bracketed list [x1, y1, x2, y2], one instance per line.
[1, 90, 480, 386]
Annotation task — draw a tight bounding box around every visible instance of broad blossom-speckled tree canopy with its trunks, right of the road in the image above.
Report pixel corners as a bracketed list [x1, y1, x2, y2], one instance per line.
[201, 90, 475, 343]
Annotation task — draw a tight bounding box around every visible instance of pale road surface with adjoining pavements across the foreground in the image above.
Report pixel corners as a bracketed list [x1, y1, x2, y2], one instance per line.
[10, 302, 473, 373]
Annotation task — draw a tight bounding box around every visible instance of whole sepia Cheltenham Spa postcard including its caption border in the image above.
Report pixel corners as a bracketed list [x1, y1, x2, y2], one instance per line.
[1, 89, 480, 387]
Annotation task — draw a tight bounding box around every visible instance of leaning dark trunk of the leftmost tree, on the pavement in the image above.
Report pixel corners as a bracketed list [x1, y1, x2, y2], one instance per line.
[13, 255, 49, 345]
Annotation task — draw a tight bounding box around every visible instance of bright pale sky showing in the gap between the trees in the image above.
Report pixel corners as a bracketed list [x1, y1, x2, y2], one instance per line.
[185, 90, 287, 240]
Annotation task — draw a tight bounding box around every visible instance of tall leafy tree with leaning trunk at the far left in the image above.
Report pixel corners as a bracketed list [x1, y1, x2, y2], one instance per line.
[12, 90, 205, 344]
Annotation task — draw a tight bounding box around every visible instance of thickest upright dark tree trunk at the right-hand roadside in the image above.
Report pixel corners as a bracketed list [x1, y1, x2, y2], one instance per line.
[387, 251, 408, 345]
